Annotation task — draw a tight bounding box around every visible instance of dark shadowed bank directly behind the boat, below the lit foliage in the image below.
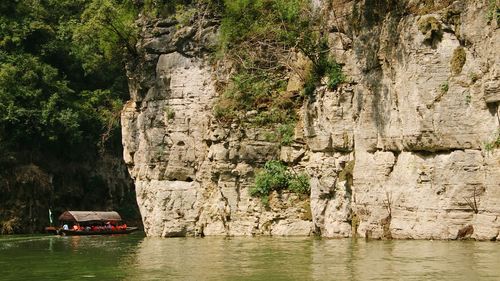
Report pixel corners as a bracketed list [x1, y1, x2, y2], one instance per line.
[0, 148, 141, 234]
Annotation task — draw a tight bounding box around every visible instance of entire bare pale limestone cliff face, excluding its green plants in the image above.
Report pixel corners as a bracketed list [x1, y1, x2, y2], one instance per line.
[122, 0, 500, 240]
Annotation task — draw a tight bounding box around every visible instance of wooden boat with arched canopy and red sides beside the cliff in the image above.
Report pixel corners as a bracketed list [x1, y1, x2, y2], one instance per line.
[51, 211, 137, 236]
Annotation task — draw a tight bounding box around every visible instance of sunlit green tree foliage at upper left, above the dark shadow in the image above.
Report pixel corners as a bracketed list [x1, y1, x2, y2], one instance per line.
[0, 0, 135, 157]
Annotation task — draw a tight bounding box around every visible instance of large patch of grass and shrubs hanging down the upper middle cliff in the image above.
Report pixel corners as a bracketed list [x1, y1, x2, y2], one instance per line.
[214, 0, 345, 126]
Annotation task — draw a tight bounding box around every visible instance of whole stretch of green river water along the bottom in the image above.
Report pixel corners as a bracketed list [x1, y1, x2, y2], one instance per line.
[0, 234, 500, 281]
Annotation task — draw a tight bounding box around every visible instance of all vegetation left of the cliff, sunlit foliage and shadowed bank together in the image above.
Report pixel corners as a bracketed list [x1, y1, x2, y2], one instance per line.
[0, 0, 141, 233]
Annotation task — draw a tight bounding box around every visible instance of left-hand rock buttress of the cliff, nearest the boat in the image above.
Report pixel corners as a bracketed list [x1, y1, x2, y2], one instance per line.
[122, 17, 312, 237]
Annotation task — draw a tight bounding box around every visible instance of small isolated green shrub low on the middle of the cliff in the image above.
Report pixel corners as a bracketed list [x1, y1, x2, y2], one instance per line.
[250, 160, 311, 204]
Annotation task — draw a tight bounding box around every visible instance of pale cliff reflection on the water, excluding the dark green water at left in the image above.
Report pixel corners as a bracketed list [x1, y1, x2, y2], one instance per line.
[129, 238, 500, 280]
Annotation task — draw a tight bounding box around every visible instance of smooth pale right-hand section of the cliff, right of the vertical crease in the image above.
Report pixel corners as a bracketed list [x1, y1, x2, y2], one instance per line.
[324, 1, 500, 240]
